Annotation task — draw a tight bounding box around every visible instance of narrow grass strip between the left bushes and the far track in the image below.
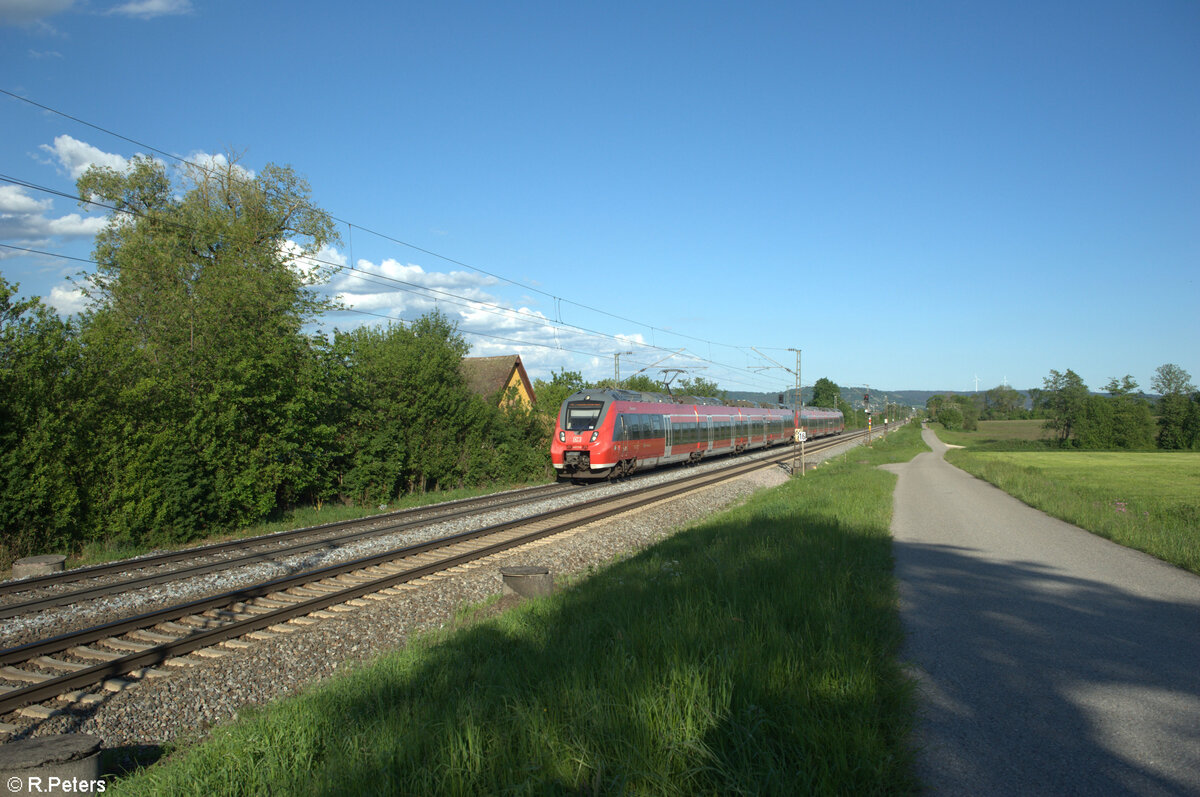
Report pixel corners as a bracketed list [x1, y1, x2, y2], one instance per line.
[66, 485, 549, 568]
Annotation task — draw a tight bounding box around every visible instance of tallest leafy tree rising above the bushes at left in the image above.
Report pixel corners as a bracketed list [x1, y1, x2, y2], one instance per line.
[78, 157, 336, 538]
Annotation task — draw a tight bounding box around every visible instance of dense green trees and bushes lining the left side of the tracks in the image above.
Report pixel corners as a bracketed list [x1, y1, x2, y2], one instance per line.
[0, 157, 550, 561]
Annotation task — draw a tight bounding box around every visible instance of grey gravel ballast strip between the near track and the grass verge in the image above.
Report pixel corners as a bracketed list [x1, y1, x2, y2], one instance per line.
[9, 441, 873, 748]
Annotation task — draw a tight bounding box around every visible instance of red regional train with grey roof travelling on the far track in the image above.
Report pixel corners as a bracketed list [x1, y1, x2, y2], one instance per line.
[550, 389, 845, 480]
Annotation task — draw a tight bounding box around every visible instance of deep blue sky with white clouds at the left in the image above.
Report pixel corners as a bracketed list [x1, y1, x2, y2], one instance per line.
[0, 0, 1200, 391]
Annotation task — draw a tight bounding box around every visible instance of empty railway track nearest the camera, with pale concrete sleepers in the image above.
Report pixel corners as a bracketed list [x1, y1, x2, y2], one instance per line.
[0, 436, 868, 727]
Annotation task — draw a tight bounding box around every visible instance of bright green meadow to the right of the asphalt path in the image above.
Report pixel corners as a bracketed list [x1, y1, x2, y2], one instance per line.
[946, 449, 1200, 574]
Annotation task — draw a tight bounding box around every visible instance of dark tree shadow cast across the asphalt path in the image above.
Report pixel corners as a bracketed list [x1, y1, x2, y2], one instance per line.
[893, 541, 1200, 795]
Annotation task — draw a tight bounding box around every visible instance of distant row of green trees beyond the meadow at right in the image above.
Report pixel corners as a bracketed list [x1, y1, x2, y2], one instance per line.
[925, 362, 1200, 450]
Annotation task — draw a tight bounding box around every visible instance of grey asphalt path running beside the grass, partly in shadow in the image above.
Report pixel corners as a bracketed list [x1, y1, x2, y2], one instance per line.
[886, 431, 1200, 796]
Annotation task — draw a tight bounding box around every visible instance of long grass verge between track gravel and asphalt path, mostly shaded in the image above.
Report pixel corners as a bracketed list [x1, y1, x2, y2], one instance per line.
[112, 429, 923, 795]
